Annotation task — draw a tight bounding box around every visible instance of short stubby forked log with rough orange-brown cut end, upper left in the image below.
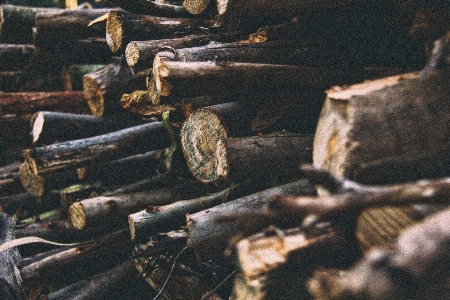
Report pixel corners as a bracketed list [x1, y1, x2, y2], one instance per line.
[83, 58, 146, 117]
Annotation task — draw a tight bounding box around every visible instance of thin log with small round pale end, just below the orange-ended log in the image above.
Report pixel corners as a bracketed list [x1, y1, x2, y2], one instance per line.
[125, 33, 241, 67]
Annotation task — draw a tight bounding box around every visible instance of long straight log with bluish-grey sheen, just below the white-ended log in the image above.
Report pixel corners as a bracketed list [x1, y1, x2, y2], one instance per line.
[19, 122, 170, 175]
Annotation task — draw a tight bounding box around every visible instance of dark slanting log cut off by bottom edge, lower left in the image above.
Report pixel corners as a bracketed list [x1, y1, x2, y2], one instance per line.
[45, 259, 139, 300]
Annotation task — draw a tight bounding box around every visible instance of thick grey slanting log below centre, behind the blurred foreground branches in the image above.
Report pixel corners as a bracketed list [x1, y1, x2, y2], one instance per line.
[186, 180, 315, 261]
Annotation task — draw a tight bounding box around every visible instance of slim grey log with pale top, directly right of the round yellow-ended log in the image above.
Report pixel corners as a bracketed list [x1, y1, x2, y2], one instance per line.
[128, 188, 230, 241]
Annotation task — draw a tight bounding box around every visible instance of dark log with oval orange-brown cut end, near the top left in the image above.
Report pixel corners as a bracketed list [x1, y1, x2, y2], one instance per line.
[106, 11, 211, 52]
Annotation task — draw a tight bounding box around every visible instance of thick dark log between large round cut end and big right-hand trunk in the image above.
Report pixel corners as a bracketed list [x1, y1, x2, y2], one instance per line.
[214, 134, 313, 183]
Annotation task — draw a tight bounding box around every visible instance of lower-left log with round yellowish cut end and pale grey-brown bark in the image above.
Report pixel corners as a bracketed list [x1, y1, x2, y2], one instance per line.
[69, 189, 180, 229]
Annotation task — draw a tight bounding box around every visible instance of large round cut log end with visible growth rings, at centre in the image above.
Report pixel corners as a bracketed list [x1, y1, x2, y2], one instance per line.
[181, 109, 227, 183]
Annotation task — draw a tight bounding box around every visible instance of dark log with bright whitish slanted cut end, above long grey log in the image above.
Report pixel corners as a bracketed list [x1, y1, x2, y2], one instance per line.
[31, 111, 141, 145]
